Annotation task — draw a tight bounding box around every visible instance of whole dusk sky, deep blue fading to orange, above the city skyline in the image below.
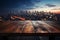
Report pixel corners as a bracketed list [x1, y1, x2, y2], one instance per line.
[0, 0, 60, 14]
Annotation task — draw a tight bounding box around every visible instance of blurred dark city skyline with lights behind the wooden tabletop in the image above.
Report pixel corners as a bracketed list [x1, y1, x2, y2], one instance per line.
[0, 11, 60, 21]
